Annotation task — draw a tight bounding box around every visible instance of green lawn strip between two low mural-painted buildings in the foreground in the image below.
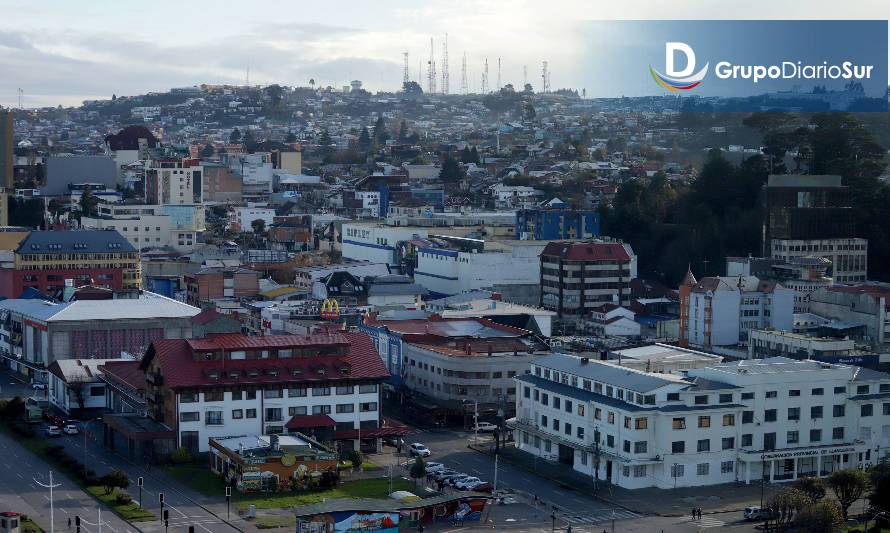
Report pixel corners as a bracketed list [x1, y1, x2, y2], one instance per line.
[233, 477, 414, 509]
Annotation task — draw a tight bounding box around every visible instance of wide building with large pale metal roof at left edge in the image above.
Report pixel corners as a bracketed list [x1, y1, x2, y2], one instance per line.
[0, 292, 201, 381]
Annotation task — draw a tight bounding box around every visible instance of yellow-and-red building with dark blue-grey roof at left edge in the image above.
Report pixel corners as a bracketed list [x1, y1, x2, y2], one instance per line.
[0, 230, 142, 298]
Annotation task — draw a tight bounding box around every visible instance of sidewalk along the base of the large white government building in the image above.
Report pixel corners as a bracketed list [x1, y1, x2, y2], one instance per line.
[470, 444, 780, 517]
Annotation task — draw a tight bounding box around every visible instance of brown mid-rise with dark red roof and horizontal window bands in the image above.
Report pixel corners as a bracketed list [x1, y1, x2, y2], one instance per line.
[540, 241, 637, 318]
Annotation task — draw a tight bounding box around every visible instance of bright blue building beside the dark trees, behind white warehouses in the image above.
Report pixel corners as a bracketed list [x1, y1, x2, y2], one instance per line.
[516, 201, 600, 241]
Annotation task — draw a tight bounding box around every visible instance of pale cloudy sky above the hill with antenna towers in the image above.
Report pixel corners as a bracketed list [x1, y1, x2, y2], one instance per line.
[0, 0, 890, 107]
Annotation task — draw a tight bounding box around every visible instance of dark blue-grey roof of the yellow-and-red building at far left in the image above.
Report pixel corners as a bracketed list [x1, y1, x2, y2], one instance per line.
[16, 230, 136, 254]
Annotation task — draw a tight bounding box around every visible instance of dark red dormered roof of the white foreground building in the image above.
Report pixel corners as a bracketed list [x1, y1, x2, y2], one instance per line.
[142, 332, 389, 389]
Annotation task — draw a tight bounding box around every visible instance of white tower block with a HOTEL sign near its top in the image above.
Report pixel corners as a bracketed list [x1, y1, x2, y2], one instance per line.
[145, 159, 204, 205]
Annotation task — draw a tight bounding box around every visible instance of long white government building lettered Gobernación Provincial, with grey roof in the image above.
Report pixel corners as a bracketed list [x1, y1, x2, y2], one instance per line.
[508, 354, 890, 489]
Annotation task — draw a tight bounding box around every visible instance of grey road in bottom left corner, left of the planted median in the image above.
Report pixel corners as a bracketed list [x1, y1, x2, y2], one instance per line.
[0, 433, 139, 533]
